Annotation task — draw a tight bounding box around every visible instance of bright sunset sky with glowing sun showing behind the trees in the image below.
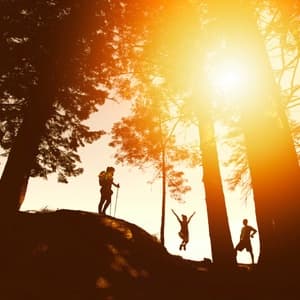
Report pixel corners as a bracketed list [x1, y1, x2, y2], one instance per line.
[0, 1, 300, 263]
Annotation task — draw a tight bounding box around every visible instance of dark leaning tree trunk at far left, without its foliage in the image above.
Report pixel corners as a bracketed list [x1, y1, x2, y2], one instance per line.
[0, 1, 97, 217]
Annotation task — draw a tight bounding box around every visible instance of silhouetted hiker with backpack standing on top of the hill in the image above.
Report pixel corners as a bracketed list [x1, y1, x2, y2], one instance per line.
[98, 167, 120, 214]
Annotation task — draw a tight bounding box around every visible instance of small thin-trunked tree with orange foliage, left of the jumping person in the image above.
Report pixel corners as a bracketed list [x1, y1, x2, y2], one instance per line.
[110, 88, 199, 245]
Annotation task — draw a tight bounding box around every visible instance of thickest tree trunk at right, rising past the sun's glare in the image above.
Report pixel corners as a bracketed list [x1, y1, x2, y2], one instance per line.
[211, 0, 300, 266]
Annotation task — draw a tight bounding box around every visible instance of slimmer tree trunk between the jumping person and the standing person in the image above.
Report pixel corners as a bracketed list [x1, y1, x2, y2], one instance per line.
[198, 95, 236, 268]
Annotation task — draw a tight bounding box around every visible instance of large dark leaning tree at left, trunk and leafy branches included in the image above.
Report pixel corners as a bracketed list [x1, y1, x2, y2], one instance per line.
[0, 0, 157, 212]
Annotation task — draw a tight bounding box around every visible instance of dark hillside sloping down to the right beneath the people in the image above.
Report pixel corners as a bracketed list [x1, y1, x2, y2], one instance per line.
[0, 210, 294, 300]
